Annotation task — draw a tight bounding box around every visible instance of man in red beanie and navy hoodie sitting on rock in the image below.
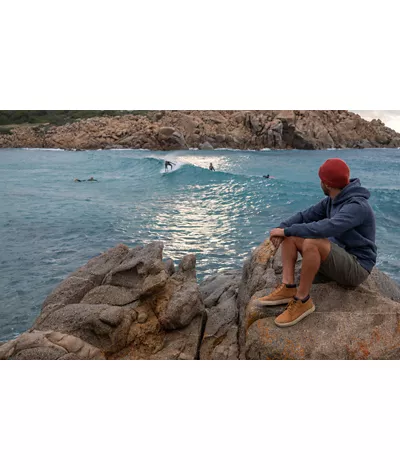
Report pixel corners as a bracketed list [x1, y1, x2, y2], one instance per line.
[257, 158, 376, 327]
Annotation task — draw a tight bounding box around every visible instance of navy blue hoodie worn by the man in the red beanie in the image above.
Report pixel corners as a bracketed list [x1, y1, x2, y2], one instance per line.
[279, 178, 376, 272]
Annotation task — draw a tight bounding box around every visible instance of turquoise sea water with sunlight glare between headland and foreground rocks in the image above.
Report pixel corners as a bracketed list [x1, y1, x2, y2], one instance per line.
[0, 149, 400, 341]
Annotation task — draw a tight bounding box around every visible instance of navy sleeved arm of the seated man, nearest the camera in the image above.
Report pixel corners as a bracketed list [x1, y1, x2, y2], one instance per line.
[284, 202, 365, 238]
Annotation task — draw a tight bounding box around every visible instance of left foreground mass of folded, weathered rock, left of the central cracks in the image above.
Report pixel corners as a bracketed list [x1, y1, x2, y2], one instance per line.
[0, 242, 206, 359]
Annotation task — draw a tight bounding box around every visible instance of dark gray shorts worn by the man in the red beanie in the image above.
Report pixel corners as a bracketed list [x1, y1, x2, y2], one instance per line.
[314, 242, 369, 287]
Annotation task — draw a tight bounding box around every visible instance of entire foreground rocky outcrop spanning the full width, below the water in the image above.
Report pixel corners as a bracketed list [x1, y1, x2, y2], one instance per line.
[0, 240, 400, 360]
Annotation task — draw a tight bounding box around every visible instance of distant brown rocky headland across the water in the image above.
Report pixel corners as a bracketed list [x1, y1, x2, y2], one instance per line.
[0, 111, 400, 150]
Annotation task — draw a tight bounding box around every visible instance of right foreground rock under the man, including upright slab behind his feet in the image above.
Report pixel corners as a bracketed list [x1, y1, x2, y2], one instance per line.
[239, 241, 400, 359]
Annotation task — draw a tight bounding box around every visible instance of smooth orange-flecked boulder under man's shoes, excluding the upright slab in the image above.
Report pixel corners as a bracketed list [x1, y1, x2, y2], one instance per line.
[246, 283, 400, 359]
